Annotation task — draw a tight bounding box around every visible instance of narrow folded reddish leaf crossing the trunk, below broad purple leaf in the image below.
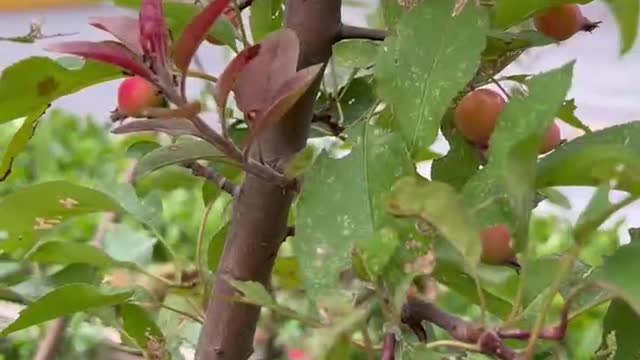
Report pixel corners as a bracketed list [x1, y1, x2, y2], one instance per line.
[246, 64, 323, 146]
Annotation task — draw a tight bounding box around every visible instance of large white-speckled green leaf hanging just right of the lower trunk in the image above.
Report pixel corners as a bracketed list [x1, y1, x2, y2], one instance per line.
[293, 121, 415, 299]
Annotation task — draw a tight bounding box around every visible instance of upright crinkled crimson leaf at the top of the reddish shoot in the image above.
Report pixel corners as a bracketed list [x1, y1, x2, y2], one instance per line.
[138, 0, 171, 63]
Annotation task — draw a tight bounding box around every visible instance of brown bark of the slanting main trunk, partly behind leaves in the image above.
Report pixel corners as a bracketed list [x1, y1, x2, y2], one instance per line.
[196, 0, 341, 360]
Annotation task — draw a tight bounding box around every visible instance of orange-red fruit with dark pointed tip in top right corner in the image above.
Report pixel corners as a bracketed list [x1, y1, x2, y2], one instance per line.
[533, 4, 599, 41]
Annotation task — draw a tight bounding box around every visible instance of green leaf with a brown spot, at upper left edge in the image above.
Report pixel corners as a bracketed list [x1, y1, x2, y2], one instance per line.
[0, 57, 124, 124]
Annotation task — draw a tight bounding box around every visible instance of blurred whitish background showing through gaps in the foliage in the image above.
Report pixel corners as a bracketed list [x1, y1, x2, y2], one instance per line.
[0, 0, 640, 238]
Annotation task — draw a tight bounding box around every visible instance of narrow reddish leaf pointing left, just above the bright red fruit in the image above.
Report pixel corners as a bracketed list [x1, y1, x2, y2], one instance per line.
[45, 41, 153, 80]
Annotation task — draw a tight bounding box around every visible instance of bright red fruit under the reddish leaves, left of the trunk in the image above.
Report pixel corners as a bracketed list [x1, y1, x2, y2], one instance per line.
[118, 76, 162, 116]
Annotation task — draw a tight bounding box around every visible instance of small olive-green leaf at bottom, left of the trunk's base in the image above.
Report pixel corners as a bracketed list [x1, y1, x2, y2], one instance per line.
[119, 303, 164, 350]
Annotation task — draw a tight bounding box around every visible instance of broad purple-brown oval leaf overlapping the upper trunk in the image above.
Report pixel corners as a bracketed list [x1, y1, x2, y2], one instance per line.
[233, 29, 300, 114]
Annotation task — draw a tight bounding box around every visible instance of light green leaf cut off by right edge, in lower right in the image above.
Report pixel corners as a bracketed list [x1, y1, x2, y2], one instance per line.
[589, 241, 640, 314]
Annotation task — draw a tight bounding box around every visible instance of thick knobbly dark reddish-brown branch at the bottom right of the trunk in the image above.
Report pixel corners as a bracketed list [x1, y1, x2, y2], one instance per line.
[402, 298, 518, 360]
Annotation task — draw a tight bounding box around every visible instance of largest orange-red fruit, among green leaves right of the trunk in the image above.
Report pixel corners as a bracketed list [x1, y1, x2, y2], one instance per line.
[454, 89, 505, 146]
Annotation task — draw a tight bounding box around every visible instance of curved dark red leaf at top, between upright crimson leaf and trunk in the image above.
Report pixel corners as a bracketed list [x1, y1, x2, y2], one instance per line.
[173, 0, 231, 73]
